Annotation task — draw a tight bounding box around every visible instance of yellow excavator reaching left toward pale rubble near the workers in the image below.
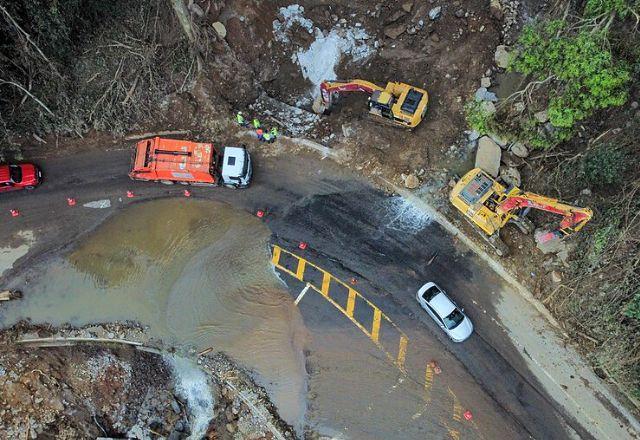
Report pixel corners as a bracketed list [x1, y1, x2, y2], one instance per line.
[313, 79, 429, 128]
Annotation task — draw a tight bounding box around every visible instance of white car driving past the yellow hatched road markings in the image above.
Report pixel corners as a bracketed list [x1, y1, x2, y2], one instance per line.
[416, 282, 473, 342]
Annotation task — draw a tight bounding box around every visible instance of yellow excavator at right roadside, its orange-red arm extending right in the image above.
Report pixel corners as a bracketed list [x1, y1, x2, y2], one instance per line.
[449, 168, 593, 256]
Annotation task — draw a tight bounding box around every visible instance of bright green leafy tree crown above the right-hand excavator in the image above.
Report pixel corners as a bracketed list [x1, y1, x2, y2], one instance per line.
[510, 20, 631, 129]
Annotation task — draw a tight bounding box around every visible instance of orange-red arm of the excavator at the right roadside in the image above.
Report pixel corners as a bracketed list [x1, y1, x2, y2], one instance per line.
[496, 192, 593, 237]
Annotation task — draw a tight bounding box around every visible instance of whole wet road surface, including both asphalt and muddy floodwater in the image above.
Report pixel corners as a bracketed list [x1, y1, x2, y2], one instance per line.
[0, 151, 608, 439]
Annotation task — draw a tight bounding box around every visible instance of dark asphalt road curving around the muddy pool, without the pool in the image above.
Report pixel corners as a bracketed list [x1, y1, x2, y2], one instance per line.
[0, 150, 591, 439]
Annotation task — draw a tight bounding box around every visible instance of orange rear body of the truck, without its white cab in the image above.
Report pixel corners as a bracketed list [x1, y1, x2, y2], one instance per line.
[129, 137, 219, 185]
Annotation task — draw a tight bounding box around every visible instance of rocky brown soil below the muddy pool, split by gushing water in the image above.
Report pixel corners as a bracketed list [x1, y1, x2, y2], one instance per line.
[0, 323, 294, 440]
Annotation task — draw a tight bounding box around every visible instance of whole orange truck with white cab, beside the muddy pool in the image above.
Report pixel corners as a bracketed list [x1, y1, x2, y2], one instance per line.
[129, 137, 253, 188]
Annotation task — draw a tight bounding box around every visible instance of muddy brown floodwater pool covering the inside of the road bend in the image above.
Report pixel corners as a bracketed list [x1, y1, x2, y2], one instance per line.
[0, 199, 306, 427]
